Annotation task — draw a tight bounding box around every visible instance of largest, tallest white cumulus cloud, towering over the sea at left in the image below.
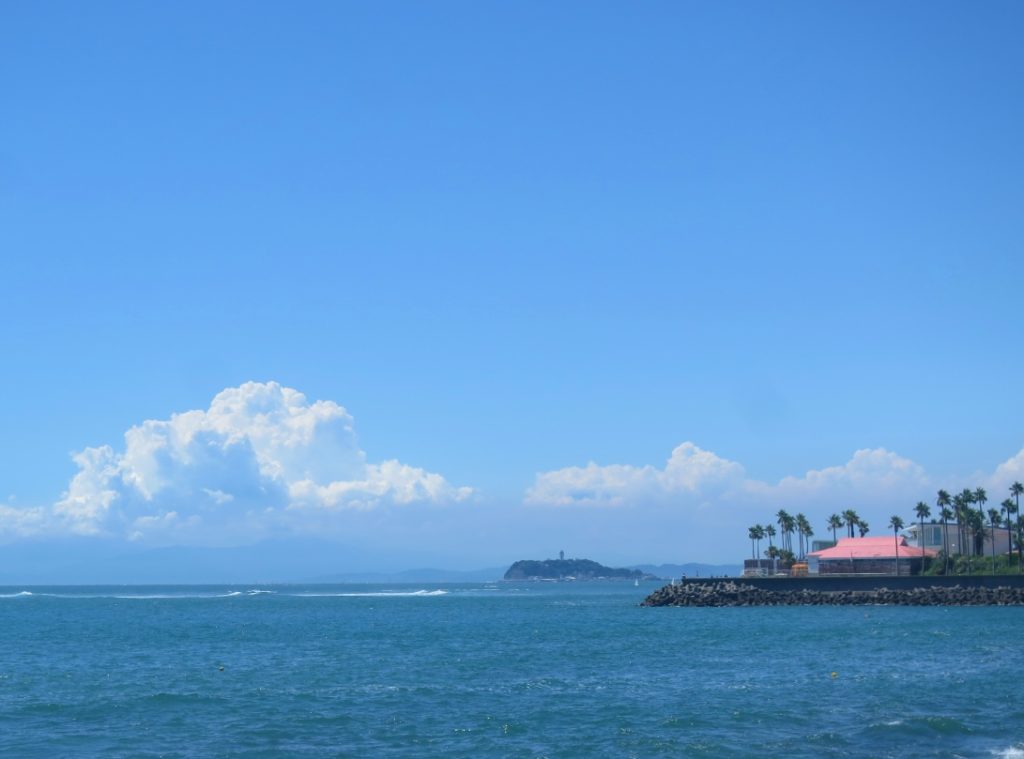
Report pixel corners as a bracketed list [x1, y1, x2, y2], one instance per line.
[30, 382, 472, 540]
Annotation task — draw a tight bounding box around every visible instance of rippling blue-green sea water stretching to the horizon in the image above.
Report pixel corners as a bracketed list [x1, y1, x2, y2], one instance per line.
[0, 583, 1024, 757]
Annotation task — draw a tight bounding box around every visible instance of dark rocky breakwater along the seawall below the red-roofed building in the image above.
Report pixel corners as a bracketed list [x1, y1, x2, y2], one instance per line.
[640, 581, 1024, 606]
